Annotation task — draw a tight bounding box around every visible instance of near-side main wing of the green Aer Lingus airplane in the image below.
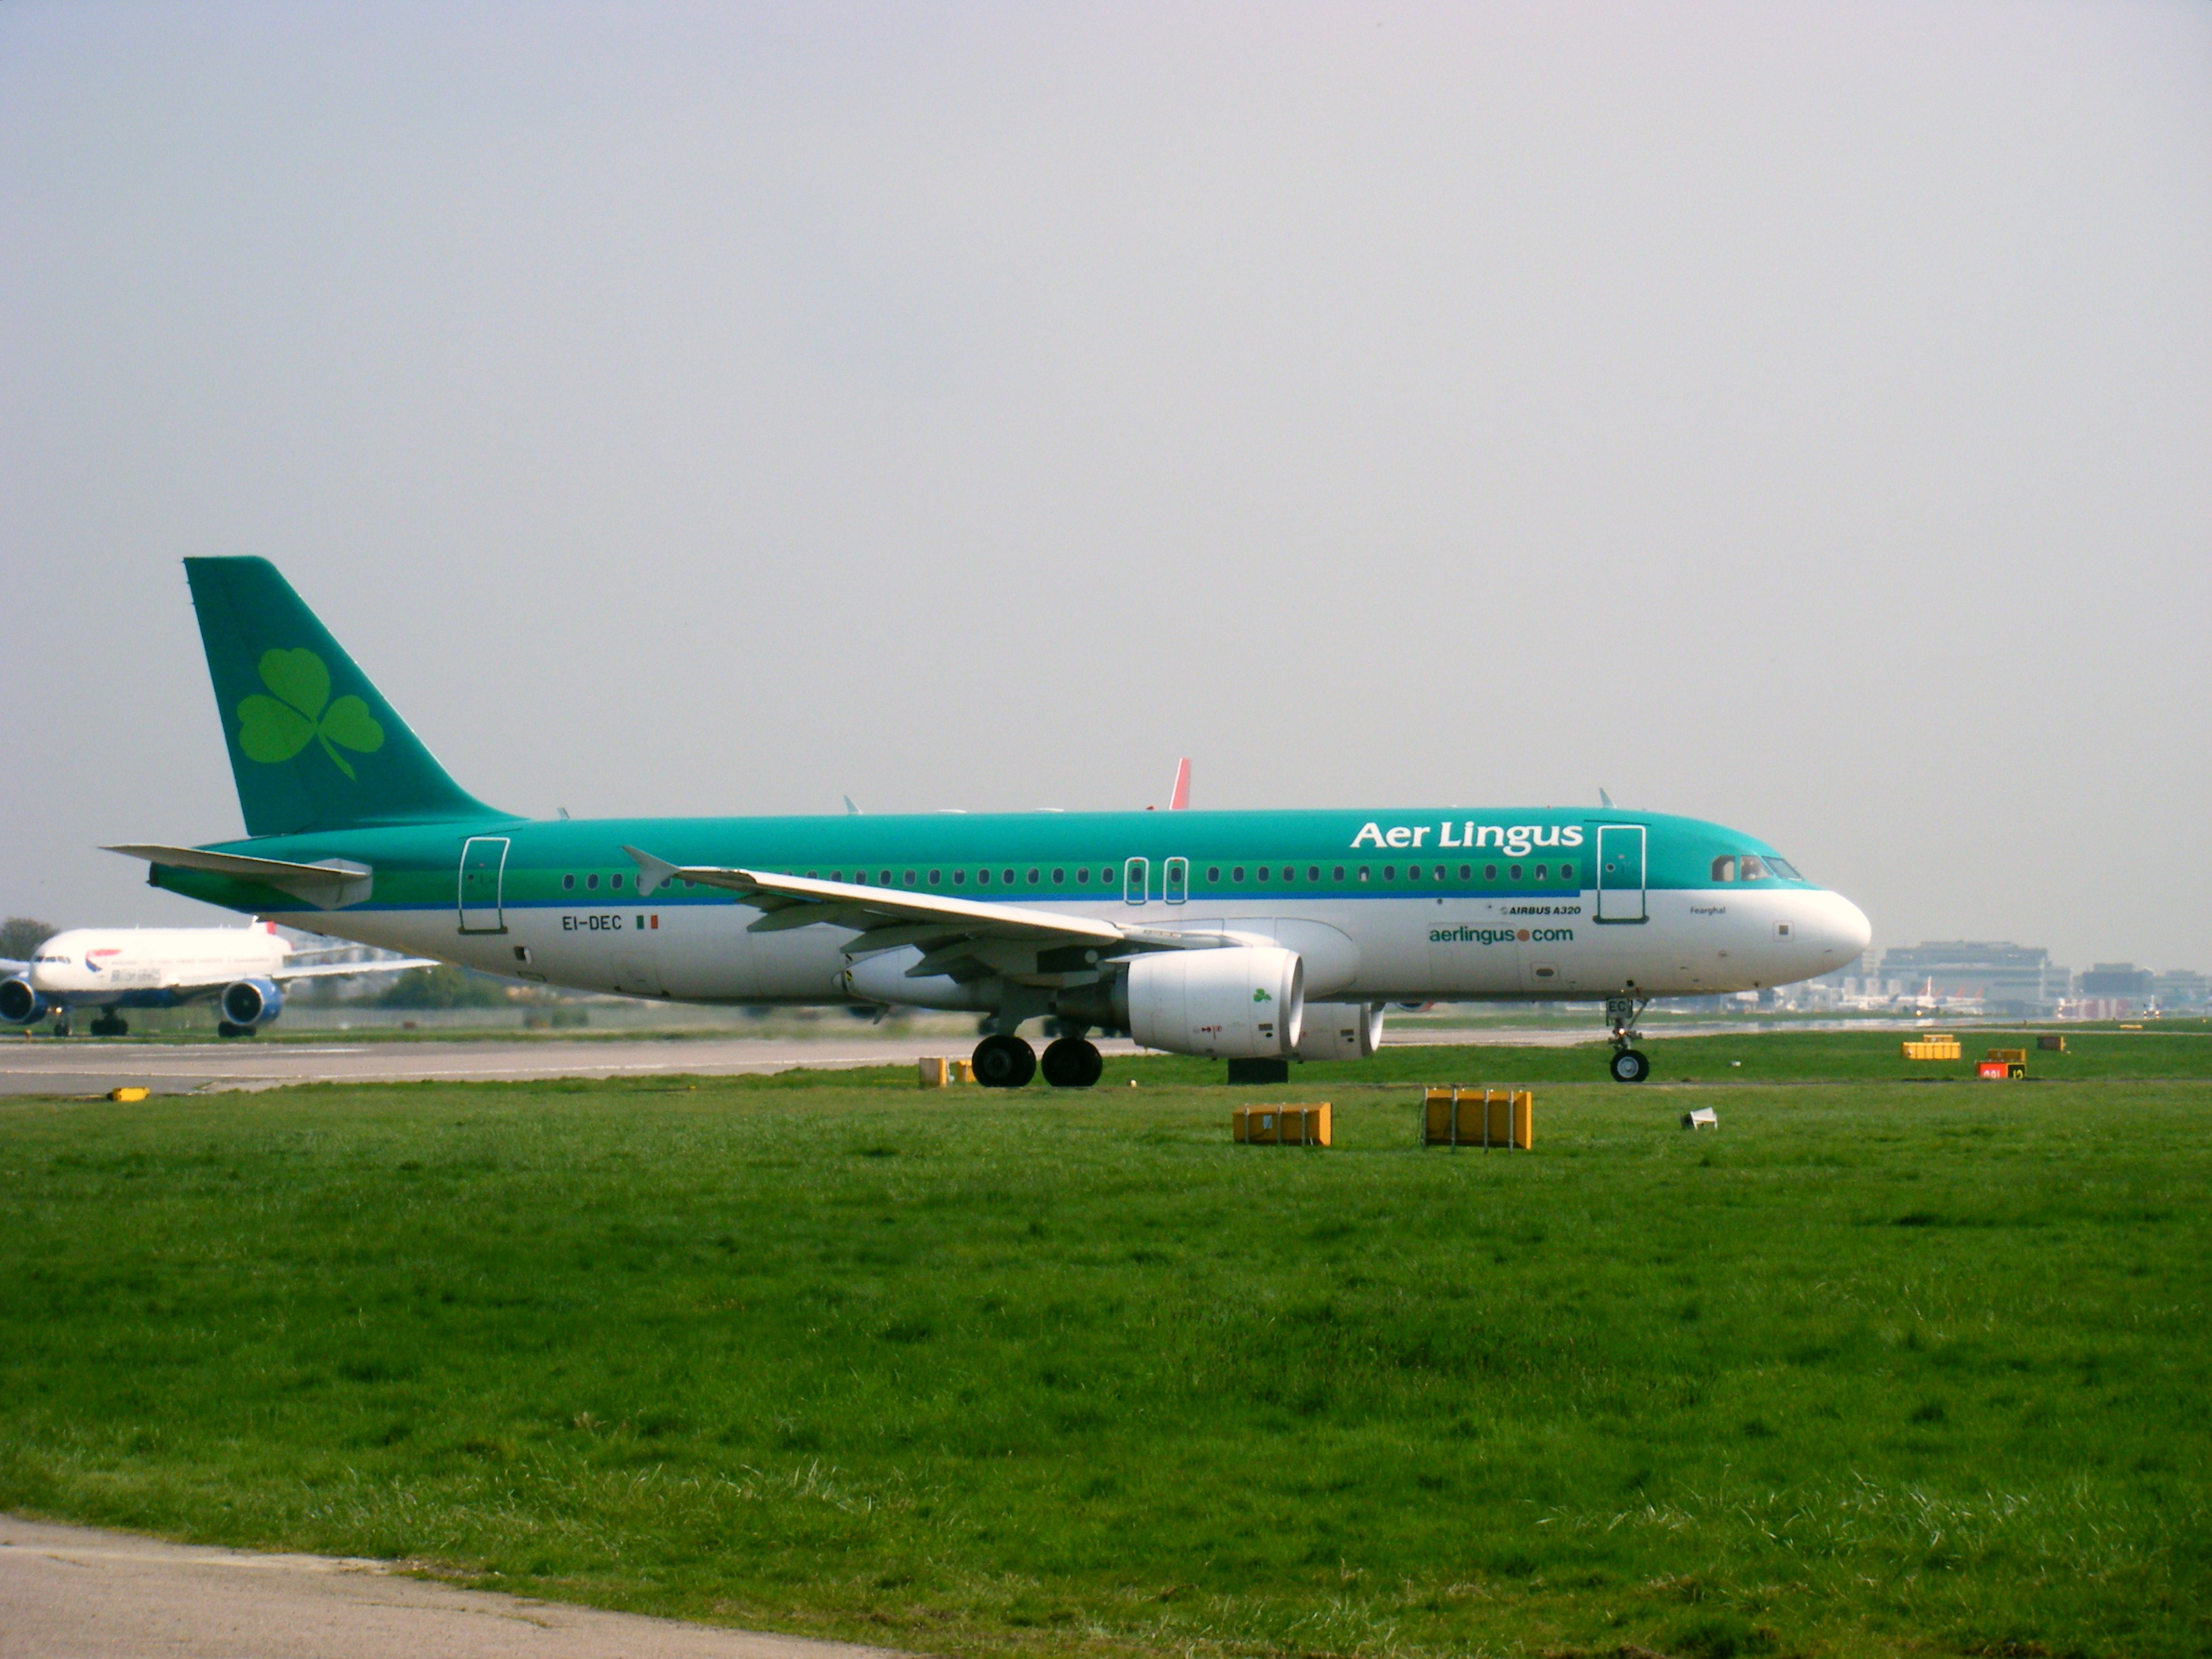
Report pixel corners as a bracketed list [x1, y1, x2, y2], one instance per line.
[623, 847, 1243, 980]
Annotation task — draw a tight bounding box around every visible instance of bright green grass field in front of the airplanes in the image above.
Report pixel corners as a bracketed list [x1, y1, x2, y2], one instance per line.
[0, 1033, 2212, 1659]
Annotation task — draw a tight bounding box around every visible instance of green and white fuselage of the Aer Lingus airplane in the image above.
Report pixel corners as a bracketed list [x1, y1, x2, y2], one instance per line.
[152, 807, 1867, 1008]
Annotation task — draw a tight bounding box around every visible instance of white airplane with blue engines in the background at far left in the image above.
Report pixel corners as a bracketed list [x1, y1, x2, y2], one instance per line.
[0, 920, 438, 1038]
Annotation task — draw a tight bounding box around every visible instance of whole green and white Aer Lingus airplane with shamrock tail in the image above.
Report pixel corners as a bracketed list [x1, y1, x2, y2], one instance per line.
[99, 558, 1867, 1088]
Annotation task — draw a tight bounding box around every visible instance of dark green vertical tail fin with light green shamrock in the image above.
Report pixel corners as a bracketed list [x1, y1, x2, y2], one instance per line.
[184, 560, 506, 836]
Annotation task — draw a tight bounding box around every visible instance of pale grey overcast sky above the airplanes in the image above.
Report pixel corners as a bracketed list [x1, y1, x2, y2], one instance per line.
[0, 0, 2212, 969]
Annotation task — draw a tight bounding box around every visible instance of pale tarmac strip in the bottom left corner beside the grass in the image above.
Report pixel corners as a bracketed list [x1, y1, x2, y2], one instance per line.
[0, 1515, 889, 1659]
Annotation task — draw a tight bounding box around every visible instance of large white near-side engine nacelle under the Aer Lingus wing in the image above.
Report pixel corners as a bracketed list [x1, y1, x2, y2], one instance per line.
[1117, 945, 1305, 1059]
